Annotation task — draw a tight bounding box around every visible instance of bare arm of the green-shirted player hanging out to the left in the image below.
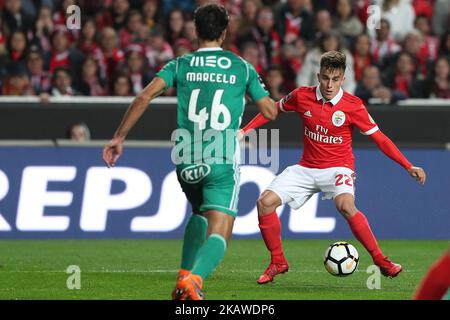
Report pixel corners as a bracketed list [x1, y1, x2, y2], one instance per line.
[103, 77, 166, 167]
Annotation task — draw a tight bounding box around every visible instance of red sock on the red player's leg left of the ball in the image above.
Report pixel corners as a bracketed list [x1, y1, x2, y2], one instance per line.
[258, 211, 286, 263]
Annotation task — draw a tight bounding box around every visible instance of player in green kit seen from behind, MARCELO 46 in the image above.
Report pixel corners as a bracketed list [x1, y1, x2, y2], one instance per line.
[103, 4, 277, 300]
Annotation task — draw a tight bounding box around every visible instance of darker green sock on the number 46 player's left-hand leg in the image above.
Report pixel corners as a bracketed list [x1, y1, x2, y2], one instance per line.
[181, 214, 208, 270]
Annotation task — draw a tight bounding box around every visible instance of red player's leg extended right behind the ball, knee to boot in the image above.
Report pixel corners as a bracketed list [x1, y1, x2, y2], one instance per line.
[334, 193, 403, 278]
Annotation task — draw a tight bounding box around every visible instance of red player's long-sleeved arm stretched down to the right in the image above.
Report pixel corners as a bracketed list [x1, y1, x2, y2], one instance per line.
[351, 101, 426, 184]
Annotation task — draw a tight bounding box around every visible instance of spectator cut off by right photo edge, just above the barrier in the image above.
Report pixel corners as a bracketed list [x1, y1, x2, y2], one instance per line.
[422, 56, 450, 99]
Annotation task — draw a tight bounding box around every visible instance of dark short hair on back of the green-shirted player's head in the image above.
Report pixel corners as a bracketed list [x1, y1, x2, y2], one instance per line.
[194, 4, 230, 41]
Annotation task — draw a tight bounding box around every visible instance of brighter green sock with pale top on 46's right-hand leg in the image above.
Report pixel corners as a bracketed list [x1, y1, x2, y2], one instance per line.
[192, 233, 227, 280]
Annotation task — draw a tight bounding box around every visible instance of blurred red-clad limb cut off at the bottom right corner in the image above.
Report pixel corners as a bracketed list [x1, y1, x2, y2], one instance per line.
[414, 252, 450, 300]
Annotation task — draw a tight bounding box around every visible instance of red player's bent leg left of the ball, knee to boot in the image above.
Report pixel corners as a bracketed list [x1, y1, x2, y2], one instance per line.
[257, 190, 289, 284]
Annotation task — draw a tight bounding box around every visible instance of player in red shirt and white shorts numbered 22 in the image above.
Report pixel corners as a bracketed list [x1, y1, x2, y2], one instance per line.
[241, 51, 426, 284]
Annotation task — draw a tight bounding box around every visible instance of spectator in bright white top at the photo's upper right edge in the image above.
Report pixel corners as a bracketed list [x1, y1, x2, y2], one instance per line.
[381, 0, 416, 42]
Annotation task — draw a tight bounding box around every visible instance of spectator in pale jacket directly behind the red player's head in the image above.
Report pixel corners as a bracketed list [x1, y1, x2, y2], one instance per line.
[297, 31, 356, 94]
